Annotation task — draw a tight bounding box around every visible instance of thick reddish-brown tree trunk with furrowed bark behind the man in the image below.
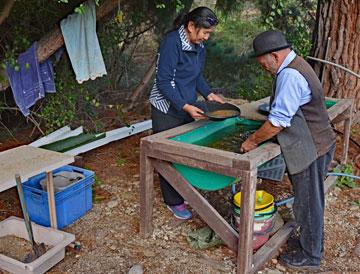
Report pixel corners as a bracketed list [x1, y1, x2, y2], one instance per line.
[312, 0, 360, 110]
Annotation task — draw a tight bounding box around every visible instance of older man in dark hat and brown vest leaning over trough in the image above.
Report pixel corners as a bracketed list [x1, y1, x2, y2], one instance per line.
[240, 30, 335, 270]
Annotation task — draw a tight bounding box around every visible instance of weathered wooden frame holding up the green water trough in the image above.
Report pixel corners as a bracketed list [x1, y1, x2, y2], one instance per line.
[140, 99, 353, 273]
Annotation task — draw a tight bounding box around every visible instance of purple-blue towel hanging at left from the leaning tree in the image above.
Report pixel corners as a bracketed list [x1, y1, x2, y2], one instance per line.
[6, 42, 56, 116]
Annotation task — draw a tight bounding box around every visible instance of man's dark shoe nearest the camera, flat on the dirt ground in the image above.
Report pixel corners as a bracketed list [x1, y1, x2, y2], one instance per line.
[279, 250, 320, 271]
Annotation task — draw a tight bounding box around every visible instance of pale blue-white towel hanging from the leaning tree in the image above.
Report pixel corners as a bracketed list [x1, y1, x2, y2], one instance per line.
[60, 0, 107, 84]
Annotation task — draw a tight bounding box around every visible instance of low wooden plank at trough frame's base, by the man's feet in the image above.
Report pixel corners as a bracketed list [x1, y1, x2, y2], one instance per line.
[251, 221, 296, 273]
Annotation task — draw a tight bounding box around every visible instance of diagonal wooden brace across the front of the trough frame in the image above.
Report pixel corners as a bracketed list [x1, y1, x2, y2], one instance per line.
[153, 160, 238, 251]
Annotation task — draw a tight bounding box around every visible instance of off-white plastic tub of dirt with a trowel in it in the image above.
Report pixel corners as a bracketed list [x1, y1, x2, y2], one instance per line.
[0, 217, 75, 274]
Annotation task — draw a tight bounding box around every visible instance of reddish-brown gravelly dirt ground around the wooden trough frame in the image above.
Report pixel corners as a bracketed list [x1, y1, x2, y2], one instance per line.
[0, 124, 360, 274]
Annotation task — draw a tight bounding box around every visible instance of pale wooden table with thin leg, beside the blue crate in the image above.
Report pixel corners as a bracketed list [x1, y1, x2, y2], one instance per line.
[0, 145, 74, 228]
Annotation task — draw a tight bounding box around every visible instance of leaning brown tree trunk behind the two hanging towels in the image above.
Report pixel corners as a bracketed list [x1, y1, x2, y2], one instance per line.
[0, 0, 118, 90]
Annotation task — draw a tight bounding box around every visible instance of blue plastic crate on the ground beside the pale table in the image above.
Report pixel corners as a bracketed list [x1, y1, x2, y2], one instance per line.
[23, 166, 94, 229]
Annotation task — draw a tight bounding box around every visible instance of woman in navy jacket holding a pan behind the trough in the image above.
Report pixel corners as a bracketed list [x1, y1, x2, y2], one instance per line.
[150, 7, 224, 219]
